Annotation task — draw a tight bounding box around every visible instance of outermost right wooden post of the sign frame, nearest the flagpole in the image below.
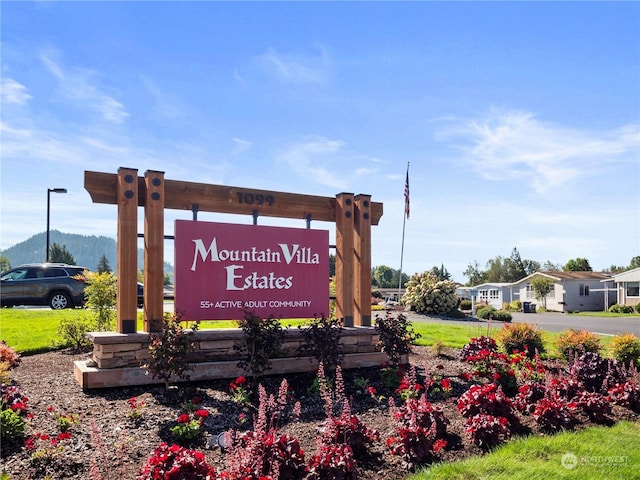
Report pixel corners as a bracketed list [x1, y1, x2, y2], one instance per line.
[353, 195, 371, 327]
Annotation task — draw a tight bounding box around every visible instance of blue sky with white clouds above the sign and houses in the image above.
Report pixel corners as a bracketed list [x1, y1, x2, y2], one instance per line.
[0, 1, 640, 282]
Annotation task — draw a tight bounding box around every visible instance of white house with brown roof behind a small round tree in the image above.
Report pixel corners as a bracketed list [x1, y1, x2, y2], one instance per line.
[513, 272, 616, 312]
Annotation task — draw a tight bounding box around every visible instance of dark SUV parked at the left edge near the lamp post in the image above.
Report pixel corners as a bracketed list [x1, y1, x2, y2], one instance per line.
[0, 263, 86, 310]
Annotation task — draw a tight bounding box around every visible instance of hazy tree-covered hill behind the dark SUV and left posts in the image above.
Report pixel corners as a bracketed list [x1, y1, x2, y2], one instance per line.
[0, 230, 173, 274]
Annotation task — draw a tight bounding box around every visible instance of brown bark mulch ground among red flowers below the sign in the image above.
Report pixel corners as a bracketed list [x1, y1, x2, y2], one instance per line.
[2, 324, 639, 480]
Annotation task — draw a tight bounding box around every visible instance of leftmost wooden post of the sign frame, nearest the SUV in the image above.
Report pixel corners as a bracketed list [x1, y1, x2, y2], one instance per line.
[116, 167, 138, 333]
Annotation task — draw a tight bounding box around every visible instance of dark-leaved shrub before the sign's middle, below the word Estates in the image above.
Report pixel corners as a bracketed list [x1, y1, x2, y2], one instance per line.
[234, 310, 285, 379]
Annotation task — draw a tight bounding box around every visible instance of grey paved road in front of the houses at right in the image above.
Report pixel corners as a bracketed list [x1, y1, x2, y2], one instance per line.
[405, 312, 640, 337]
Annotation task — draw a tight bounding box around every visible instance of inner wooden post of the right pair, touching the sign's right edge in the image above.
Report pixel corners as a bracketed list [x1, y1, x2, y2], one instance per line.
[336, 193, 355, 327]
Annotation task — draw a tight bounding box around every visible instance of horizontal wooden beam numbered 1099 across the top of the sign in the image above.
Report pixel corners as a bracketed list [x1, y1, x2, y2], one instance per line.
[84, 171, 383, 225]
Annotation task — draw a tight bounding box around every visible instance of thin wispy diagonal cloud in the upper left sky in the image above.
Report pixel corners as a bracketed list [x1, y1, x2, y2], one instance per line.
[40, 54, 129, 123]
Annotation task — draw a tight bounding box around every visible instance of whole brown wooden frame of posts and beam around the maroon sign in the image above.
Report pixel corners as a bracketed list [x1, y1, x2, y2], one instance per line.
[84, 167, 383, 333]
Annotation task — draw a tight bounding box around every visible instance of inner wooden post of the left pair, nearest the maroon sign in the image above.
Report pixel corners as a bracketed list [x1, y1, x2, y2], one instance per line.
[144, 170, 165, 332]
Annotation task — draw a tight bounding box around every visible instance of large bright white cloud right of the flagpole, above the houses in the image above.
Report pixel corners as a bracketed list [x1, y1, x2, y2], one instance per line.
[437, 109, 640, 194]
